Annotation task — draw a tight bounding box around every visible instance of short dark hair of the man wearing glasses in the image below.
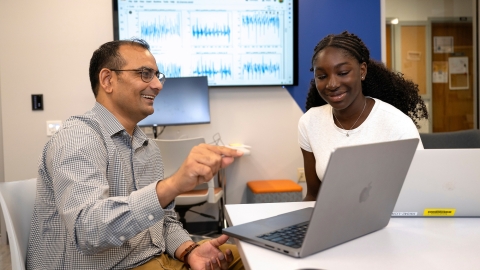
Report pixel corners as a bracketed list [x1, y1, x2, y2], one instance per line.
[89, 38, 150, 97]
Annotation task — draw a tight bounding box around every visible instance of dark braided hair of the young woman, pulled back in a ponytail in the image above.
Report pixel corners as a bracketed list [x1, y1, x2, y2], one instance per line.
[306, 31, 428, 127]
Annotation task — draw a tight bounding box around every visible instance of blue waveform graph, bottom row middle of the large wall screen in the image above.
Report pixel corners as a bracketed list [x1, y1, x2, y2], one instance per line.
[192, 54, 233, 84]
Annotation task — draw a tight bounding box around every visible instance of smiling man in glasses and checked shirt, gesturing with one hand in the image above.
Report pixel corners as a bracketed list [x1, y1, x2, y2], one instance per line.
[27, 40, 243, 269]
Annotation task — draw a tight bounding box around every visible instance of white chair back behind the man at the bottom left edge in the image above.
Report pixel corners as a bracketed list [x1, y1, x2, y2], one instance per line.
[0, 178, 37, 270]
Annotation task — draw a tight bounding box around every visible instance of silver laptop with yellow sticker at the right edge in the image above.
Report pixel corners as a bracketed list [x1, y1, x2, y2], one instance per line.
[392, 149, 480, 217]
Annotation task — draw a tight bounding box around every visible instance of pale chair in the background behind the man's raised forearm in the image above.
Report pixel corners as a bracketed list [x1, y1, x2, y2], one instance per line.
[154, 138, 224, 230]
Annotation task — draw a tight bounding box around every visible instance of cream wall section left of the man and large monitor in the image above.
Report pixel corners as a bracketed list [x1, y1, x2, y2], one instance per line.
[0, 0, 113, 181]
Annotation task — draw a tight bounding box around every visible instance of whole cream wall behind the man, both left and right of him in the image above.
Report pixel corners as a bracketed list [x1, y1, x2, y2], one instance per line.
[0, 0, 303, 211]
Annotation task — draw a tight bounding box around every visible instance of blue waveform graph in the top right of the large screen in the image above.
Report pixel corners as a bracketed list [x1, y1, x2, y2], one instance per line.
[239, 11, 282, 46]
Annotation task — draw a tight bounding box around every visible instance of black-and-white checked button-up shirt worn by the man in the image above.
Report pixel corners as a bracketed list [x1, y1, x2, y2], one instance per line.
[27, 103, 191, 269]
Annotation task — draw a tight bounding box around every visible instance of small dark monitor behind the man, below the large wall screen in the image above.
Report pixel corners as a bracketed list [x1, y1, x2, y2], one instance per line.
[138, 76, 210, 127]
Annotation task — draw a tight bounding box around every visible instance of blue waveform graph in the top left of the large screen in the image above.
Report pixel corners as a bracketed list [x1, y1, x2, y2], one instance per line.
[139, 11, 182, 48]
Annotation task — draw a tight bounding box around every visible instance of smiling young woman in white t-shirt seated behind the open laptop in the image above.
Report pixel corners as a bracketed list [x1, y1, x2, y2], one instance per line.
[298, 32, 428, 201]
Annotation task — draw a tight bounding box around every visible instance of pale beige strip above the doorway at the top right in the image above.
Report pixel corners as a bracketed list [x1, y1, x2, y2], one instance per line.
[385, 0, 474, 21]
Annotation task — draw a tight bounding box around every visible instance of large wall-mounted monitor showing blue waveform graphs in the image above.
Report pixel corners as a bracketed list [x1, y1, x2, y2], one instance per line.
[113, 0, 298, 86]
